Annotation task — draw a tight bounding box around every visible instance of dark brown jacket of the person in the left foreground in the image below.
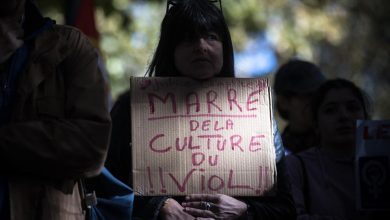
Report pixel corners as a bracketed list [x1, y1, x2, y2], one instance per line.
[0, 2, 111, 220]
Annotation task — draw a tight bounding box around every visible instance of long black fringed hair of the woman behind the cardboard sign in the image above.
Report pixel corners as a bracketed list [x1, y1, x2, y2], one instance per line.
[146, 0, 234, 77]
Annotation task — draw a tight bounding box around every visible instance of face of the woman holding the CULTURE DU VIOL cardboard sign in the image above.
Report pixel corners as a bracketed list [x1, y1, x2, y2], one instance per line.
[174, 32, 223, 79]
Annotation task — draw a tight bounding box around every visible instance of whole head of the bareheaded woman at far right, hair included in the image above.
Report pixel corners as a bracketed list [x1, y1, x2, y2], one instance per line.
[311, 79, 370, 148]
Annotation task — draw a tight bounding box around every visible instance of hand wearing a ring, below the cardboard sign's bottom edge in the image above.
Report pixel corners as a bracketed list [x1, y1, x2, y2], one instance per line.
[182, 194, 247, 219]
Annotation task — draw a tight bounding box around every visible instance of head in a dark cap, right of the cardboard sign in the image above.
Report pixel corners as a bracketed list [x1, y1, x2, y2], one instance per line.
[274, 59, 325, 132]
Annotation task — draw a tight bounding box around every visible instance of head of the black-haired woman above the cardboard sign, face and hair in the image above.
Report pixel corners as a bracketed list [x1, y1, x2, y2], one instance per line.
[147, 0, 234, 79]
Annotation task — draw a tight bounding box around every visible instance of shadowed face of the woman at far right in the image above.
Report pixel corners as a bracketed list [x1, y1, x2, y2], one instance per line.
[317, 88, 365, 148]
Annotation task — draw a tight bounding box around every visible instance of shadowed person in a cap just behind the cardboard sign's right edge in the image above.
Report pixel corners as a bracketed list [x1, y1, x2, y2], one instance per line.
[274, 59, 325, 154]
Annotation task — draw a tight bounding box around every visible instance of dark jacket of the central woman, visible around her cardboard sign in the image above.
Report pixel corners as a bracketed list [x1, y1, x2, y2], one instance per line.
[105, 92, 295, 219]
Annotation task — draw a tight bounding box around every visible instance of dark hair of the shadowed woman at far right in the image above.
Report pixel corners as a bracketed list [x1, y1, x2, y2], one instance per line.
[311, 78, 371, 123]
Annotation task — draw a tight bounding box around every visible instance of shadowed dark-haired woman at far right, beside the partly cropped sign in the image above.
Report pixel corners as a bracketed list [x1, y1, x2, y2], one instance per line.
[287, 79, 389, 219]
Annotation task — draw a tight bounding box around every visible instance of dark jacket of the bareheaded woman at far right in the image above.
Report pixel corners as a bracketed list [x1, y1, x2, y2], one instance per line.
[286, 146, 390, 220]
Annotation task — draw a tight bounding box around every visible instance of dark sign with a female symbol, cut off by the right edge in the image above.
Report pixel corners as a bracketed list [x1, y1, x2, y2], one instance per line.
[356, 120, 390, 211]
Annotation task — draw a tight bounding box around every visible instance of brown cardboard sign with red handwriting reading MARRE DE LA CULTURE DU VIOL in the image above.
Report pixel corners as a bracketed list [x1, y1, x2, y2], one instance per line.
[130, 77, 276, 196]
